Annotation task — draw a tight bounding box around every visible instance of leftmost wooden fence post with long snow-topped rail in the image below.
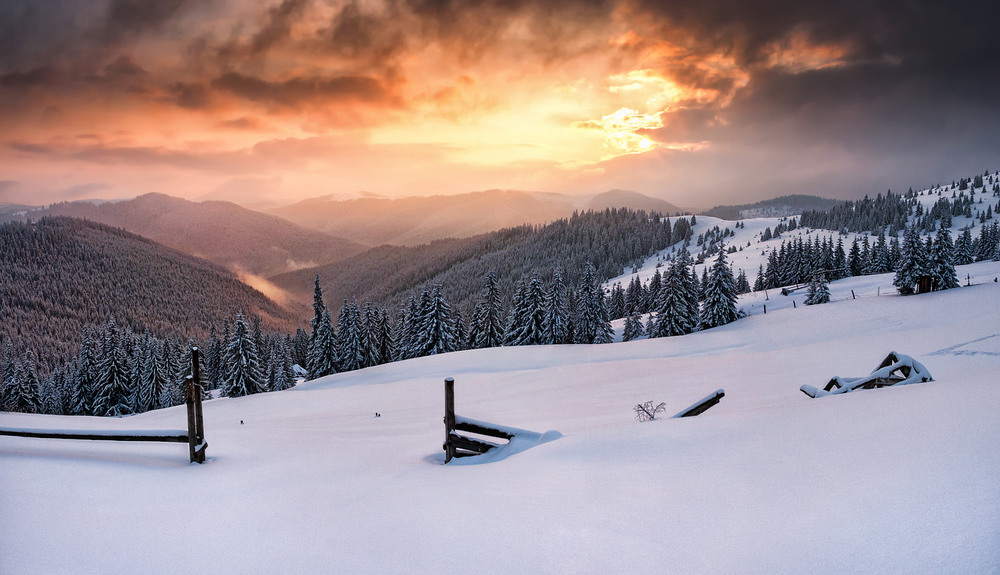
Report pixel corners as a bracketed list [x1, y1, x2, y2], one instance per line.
[0, 347, 208, 463]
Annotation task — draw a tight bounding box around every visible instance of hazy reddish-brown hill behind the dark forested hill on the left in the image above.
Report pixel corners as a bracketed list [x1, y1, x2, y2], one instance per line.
[8, 194, 367, 276]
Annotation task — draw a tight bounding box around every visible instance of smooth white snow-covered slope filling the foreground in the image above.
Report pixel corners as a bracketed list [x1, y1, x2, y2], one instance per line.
[0, 262, 1000, 574]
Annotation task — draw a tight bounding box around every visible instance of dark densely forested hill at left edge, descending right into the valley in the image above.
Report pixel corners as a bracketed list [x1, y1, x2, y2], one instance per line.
[0, 217, 297, 372]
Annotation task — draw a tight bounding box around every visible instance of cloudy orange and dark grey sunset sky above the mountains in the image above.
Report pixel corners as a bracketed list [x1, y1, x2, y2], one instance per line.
[0, 0, 1000, 207]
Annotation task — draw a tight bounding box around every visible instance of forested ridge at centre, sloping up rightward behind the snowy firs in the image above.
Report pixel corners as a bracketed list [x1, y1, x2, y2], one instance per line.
[271, 209, 690, 313]
